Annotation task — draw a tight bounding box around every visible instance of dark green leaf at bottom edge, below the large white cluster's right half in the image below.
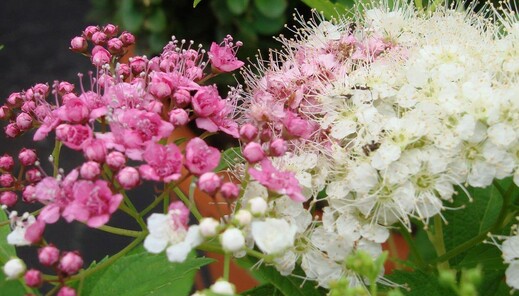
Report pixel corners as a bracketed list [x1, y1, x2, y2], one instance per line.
[386, 270, 456, 296]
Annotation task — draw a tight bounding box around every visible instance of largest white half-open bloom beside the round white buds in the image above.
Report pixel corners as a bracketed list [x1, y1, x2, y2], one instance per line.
[251, 218, 297, 254]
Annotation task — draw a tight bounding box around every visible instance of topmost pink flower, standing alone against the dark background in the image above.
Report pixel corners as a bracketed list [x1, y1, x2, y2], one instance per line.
[209, 35, 243, 72]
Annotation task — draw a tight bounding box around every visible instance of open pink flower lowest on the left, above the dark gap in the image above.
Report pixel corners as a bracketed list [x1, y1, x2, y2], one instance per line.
[63, 180, 123, 228]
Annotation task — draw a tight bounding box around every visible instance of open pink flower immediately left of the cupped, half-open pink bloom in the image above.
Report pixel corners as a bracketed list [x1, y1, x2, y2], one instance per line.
[139, 142, 182, 182]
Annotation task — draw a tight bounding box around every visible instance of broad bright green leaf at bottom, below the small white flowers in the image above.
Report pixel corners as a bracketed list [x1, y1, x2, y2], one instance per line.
[85, 253, 213, 296]
